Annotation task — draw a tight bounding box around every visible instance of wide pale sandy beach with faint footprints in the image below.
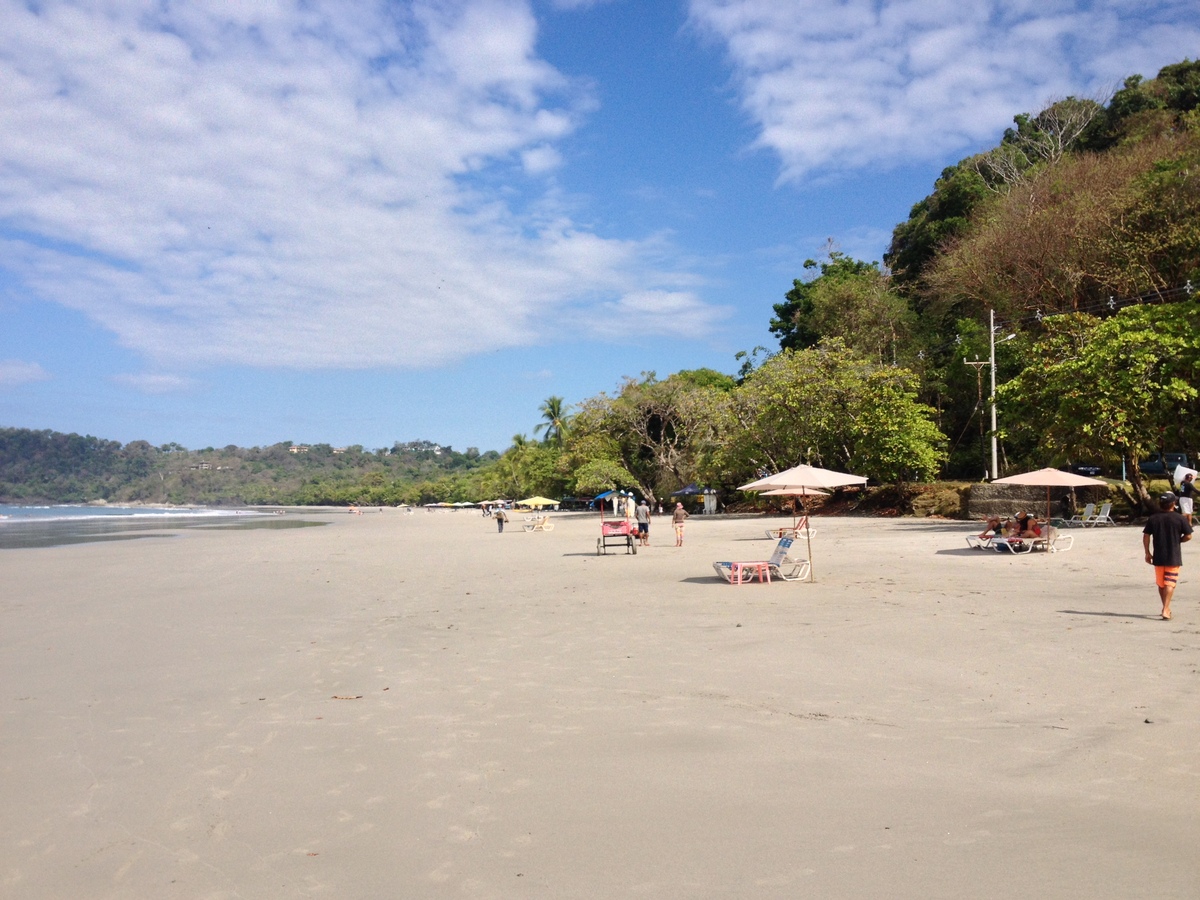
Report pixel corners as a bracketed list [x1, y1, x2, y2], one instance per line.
[0, 510, 1200, 900]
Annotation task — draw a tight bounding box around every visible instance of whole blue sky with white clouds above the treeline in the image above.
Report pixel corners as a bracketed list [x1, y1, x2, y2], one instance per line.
[0, 0, 1200, 450]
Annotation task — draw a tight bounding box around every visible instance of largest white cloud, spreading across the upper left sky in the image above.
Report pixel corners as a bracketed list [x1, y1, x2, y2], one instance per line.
[0, 0, 706, 368]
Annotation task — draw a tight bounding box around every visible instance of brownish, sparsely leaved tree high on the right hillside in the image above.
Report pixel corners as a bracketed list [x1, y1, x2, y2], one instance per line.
[925, 132, 1200, 322]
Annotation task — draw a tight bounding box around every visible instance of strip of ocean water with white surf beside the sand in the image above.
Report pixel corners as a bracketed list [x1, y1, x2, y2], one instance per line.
[0, 504, 324, 551]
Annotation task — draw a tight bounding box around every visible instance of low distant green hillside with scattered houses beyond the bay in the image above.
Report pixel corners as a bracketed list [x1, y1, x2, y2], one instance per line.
[0, 428, 498, 505]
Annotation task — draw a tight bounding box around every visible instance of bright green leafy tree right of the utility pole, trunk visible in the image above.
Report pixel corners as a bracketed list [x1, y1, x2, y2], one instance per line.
[998, 302, 1200, 512]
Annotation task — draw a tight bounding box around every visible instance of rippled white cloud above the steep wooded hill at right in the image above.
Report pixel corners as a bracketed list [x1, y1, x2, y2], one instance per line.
[691, 0, 1200, 180]
